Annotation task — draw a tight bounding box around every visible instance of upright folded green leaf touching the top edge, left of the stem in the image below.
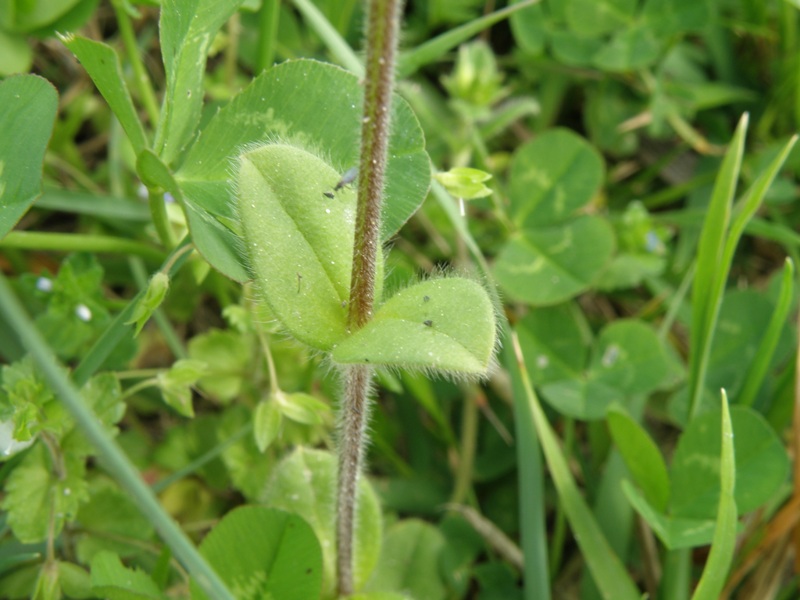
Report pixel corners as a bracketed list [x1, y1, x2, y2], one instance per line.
[155, 0, 241, 165]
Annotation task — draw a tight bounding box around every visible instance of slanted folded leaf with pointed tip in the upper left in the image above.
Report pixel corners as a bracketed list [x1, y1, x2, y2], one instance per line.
[61, 35, 147, 155]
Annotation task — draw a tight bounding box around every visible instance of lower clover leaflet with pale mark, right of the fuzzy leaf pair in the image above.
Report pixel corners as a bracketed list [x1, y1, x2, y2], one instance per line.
[494, 215, 614, 306]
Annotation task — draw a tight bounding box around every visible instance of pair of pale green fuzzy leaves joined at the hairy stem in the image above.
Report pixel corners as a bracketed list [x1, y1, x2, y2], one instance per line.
[237, 143, 496, 375]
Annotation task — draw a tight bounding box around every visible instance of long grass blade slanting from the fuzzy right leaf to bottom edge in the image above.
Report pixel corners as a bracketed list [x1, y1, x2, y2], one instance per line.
[512, 334, 641, 600]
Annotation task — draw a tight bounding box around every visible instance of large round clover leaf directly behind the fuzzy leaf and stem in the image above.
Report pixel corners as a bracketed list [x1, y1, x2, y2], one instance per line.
[176, 60, 430, 248]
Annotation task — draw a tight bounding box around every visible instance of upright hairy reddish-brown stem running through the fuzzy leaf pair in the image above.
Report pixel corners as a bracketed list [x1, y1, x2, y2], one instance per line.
[336, 0, 402, 595]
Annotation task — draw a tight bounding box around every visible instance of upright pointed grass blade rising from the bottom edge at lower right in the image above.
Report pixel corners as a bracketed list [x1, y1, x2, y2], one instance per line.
[692, 390, 738, 600]
